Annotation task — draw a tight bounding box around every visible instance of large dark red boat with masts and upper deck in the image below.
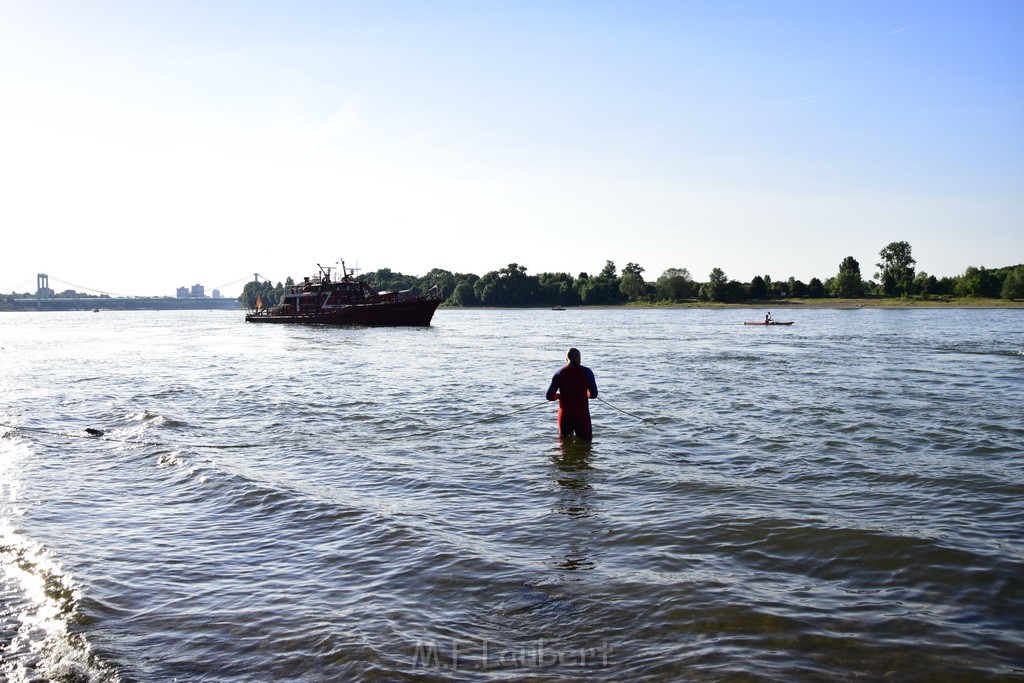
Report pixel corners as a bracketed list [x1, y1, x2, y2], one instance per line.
[246, 261, 441, 327]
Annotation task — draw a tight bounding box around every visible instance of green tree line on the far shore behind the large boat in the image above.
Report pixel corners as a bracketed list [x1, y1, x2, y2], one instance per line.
[239, 242, 1024, 308]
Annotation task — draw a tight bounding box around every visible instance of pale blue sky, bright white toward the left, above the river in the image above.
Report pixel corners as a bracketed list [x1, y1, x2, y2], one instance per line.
[0, 0, 1024, 296]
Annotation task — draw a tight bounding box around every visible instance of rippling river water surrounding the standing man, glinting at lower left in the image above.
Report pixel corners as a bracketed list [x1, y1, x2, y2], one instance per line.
[0, 309, 1024, 682]
